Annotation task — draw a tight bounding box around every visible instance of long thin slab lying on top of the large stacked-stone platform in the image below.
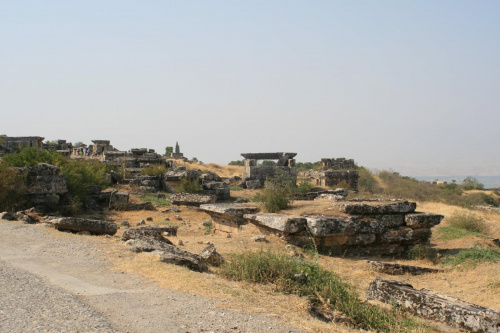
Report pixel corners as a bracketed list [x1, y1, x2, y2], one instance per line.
[338, 201, 417, 215]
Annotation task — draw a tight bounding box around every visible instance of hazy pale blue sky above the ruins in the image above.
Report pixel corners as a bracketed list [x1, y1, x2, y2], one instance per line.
[0, 0, 500, 176]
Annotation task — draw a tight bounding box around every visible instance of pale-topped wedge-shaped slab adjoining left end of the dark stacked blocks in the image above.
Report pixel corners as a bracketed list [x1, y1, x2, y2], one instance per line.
[243, 214, 307, 234]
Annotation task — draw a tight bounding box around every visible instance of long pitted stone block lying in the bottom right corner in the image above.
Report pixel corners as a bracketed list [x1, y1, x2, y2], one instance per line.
[367, 278, 500, 333]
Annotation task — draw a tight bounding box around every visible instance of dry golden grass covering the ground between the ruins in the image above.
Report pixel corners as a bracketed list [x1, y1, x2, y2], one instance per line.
[97, 164, 500, 332]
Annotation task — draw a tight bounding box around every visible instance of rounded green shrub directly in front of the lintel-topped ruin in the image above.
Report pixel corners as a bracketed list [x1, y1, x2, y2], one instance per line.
[260, 170, 295, 213]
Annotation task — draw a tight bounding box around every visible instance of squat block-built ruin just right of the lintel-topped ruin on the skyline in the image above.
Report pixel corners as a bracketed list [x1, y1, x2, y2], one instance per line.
[306, 158, 359, 190]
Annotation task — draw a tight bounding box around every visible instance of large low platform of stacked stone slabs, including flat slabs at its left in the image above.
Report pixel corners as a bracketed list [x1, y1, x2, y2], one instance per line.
[200, 200, 444, 256]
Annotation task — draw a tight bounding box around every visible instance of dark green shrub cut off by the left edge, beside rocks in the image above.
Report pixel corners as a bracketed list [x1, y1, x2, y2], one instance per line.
[0, 162, 26, 212]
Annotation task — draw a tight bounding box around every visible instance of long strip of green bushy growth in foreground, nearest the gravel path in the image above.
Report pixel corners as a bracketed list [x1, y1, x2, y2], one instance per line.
[219, 251, 417, 332]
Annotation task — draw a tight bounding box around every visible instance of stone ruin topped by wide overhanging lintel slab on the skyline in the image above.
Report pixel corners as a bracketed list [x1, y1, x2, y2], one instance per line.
[241, 153, 297, 189]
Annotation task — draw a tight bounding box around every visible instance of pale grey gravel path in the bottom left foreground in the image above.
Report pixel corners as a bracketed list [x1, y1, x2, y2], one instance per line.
[0, 221, 303, 333]
